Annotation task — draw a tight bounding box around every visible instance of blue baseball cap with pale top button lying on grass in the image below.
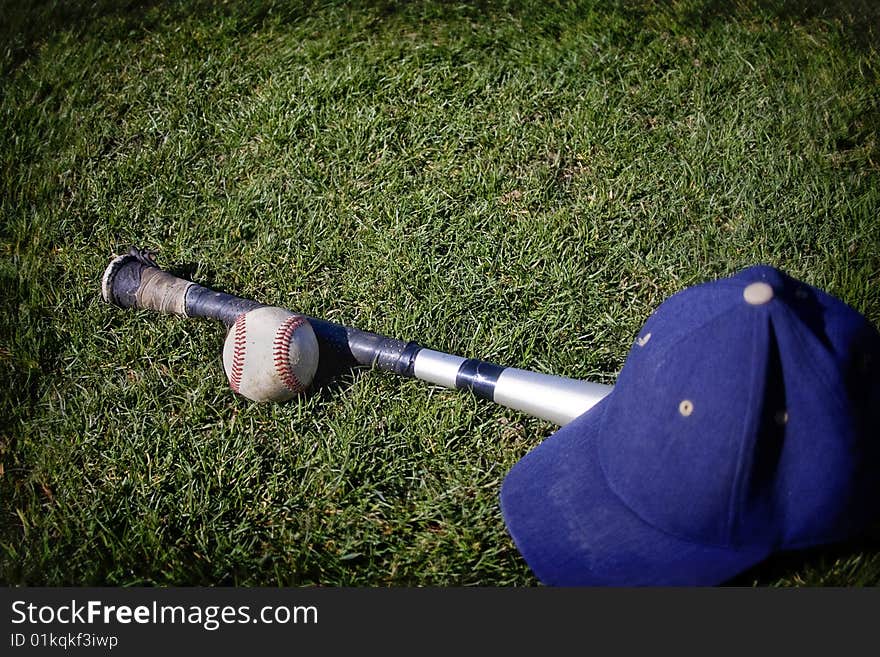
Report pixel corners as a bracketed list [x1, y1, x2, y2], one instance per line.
[501, 266, 880, 586]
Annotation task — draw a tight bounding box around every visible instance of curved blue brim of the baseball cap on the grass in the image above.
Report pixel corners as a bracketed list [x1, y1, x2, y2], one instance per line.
[501, 392, 769, 586]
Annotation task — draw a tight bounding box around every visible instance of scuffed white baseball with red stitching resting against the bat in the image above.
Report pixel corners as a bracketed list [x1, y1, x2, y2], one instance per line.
[223, 306, 318, 401]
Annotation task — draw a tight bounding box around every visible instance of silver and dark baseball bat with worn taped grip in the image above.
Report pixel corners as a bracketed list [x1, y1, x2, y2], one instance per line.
[101, 247, 611, 426]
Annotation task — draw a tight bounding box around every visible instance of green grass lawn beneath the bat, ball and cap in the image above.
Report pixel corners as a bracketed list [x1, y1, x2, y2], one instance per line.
[0, 0, 880, 586]
